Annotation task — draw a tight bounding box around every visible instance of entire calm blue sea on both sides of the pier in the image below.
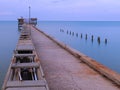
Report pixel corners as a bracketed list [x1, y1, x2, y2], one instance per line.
[0, 21, 120, 88]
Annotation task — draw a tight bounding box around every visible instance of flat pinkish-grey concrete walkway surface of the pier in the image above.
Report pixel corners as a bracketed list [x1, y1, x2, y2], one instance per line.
[31, 27, 120, 90]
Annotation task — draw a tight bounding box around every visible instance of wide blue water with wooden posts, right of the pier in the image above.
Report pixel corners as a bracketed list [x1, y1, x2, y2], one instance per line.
[38, 21, 120, 73]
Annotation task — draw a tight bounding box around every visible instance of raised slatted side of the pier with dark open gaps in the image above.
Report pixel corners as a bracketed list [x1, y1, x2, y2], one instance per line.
[2, 24, 49, 90]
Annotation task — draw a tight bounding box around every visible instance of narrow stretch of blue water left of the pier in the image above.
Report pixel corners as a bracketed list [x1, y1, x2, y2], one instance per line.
[0, 21, 19, 88]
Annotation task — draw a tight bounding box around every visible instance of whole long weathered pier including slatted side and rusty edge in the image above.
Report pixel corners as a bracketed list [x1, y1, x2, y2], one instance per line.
[2, 19, 120, 90]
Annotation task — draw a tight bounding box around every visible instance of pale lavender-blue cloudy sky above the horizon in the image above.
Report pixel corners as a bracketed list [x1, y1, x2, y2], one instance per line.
[0, 0, 120, 21]
